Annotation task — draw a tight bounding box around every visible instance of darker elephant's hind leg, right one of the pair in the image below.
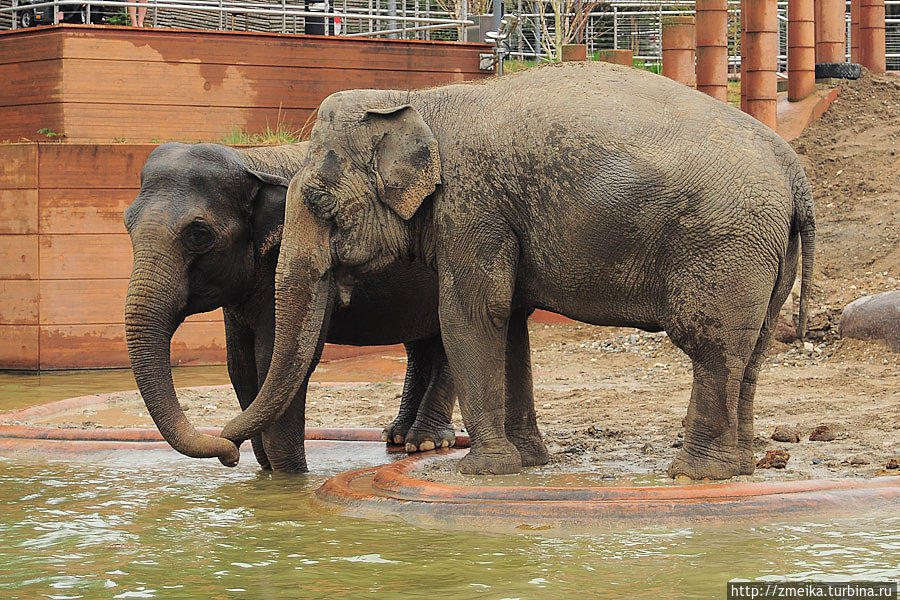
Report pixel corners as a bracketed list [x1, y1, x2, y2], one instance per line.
[406, 337, 456, 452]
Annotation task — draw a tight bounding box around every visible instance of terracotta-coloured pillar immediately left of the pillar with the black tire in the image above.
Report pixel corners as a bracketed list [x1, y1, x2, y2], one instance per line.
[788, 0, 816, 102]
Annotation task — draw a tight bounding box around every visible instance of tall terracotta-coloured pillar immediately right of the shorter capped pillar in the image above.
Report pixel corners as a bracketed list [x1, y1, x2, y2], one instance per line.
[696, 0, 728, 102]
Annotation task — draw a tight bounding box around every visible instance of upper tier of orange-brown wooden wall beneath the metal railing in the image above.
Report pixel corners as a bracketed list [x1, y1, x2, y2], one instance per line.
[0, 25, 490, 142]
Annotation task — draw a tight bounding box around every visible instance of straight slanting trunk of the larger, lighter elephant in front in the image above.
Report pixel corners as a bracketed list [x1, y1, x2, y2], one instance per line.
[222, 200, 335, 470]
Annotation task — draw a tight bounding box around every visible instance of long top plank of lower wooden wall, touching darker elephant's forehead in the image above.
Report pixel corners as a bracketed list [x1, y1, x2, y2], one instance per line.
[38, 144, 157, 189]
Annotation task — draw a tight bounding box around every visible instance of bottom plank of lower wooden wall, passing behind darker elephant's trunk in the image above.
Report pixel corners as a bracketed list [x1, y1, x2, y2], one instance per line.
[40, 323, 225, 369]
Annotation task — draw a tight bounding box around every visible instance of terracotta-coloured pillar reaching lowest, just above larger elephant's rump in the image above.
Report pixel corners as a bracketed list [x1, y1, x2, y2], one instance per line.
[741, 0, 778, 129]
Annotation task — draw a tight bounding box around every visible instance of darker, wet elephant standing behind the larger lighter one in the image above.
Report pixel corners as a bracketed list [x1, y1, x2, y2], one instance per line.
[125, 143, 455, 471]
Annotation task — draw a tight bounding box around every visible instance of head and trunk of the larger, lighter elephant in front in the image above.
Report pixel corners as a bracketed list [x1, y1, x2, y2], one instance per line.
[222, 90, 441, 462]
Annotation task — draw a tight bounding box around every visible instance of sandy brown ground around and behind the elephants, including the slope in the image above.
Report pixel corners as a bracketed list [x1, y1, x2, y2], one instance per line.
[8, 73, 900, 481]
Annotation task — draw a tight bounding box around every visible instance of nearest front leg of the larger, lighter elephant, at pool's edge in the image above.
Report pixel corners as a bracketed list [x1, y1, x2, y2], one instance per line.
[438, 237, 522, 475]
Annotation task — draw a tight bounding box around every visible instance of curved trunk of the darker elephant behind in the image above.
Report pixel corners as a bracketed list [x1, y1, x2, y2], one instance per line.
[125, 244, 240, 464]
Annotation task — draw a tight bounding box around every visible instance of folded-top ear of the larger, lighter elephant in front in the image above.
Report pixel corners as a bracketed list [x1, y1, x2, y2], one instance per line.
[365, 104, 441, 220]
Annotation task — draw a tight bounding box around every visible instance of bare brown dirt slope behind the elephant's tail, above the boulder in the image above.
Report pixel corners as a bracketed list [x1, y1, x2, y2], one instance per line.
[792, 70, 900, 337]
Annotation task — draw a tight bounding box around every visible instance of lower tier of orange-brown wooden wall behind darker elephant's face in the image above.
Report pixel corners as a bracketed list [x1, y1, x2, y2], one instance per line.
[0, 143, 225, 369]
